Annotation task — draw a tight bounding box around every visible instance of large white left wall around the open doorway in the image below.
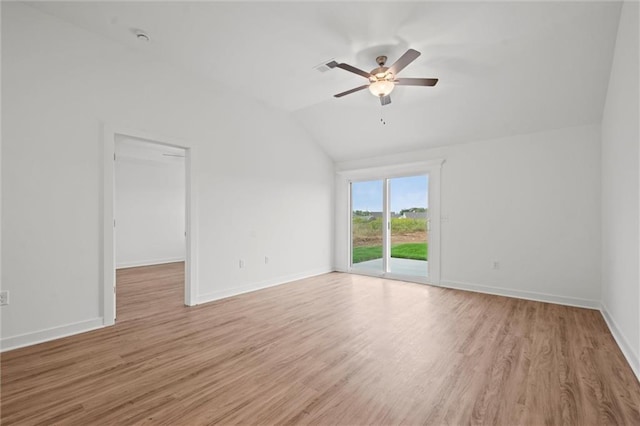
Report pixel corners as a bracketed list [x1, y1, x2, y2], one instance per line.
[1, 2, 334, 349]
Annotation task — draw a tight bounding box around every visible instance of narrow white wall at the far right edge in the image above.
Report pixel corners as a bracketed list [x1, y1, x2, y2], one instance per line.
[602, 2, 640, 377]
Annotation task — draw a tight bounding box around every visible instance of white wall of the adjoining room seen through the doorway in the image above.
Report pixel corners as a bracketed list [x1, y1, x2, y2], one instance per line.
[115, 140, 186, 268]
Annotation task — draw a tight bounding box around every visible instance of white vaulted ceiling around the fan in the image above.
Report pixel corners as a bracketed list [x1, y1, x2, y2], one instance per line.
[30, 1, 620, 161]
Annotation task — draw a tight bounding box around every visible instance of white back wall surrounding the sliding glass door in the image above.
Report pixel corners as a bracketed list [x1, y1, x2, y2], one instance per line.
[335, 125, 600, 307]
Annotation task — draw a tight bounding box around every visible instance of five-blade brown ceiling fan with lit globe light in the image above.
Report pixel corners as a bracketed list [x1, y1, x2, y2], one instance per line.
[327, 49, 438, 105]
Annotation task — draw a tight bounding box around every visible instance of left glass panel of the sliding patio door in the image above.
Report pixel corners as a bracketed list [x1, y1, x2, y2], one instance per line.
[351, 180, 385, 274]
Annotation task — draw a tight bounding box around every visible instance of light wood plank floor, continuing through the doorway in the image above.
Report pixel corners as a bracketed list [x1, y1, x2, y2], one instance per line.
[2, 264, 640, 425]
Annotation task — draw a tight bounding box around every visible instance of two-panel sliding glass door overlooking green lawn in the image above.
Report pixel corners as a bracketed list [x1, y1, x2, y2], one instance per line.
[351, 175, 429, 278]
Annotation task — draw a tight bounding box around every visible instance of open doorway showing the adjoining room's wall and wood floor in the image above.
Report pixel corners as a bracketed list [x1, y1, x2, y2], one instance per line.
[114, 135, 186, 321]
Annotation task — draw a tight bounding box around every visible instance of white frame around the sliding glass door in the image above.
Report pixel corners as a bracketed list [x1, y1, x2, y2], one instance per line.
[337, 159, 444, 285]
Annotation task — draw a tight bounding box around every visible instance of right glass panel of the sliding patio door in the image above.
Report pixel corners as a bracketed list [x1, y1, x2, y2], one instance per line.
[387, 176, 429, 277]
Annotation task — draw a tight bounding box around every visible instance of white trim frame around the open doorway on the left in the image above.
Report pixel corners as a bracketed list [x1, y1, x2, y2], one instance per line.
[101, 124, 198, 325]
